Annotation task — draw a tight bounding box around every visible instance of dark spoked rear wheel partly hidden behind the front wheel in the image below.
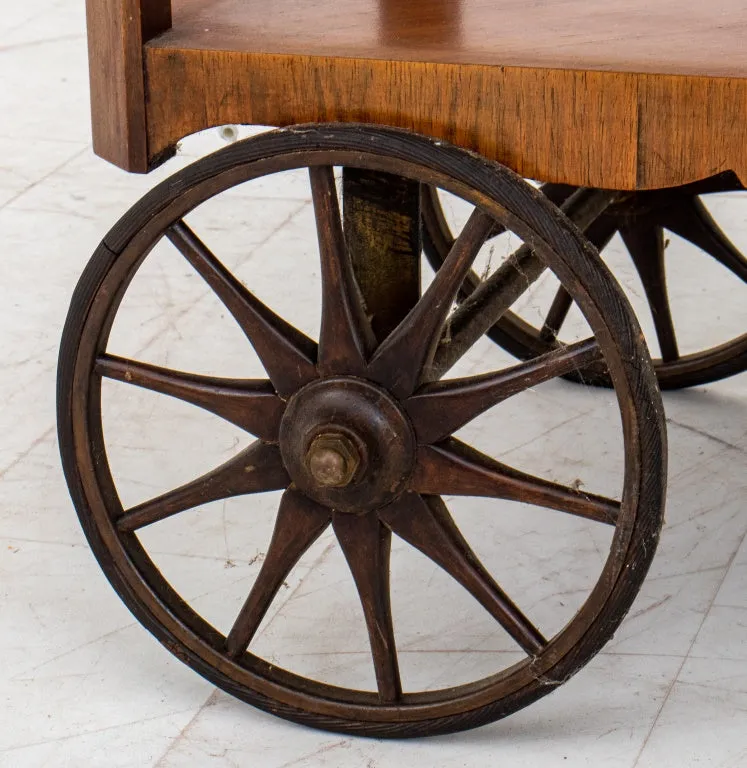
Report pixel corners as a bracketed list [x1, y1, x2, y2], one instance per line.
[423, 173, 747, 389]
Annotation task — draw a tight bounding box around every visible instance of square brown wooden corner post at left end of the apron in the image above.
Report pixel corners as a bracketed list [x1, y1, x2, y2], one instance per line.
[86, 0, 171, 173]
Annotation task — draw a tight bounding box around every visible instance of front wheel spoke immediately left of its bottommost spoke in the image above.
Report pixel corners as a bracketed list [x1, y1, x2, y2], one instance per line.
[226, 488, 332, 658]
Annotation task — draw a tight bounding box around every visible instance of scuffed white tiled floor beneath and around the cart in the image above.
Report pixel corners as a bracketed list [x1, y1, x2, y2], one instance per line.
[0, 0, 747, 768]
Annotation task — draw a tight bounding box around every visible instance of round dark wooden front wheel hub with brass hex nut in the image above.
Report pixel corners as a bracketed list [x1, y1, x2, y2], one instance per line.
[280, 376, 415, 513]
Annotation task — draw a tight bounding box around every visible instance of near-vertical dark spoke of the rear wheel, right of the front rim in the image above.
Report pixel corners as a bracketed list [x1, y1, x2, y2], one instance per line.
[620, 225, 680, 363]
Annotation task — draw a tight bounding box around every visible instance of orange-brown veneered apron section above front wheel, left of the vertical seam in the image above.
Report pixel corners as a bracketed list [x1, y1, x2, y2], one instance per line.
[145, 50, 638, 189]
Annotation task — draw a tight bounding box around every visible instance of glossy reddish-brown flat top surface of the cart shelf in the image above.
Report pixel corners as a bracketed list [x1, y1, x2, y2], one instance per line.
[163, 0, 747, 77]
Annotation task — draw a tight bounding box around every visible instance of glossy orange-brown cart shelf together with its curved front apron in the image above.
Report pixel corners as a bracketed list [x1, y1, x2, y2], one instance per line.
[89, 0, 747, 189]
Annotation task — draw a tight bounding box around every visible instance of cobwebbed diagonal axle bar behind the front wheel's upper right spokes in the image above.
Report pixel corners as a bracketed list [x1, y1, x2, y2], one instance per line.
[426, 188, 618, 380]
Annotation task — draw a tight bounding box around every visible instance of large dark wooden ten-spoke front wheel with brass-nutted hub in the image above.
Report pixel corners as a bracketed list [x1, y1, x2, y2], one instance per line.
[58, 126, 665, 736]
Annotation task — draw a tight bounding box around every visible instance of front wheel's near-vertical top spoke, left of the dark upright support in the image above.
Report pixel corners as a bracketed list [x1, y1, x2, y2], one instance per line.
[309, 166, 374, 375]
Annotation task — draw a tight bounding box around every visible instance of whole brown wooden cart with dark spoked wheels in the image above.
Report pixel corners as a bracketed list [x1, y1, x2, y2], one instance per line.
[59, 0, 747, 736]
